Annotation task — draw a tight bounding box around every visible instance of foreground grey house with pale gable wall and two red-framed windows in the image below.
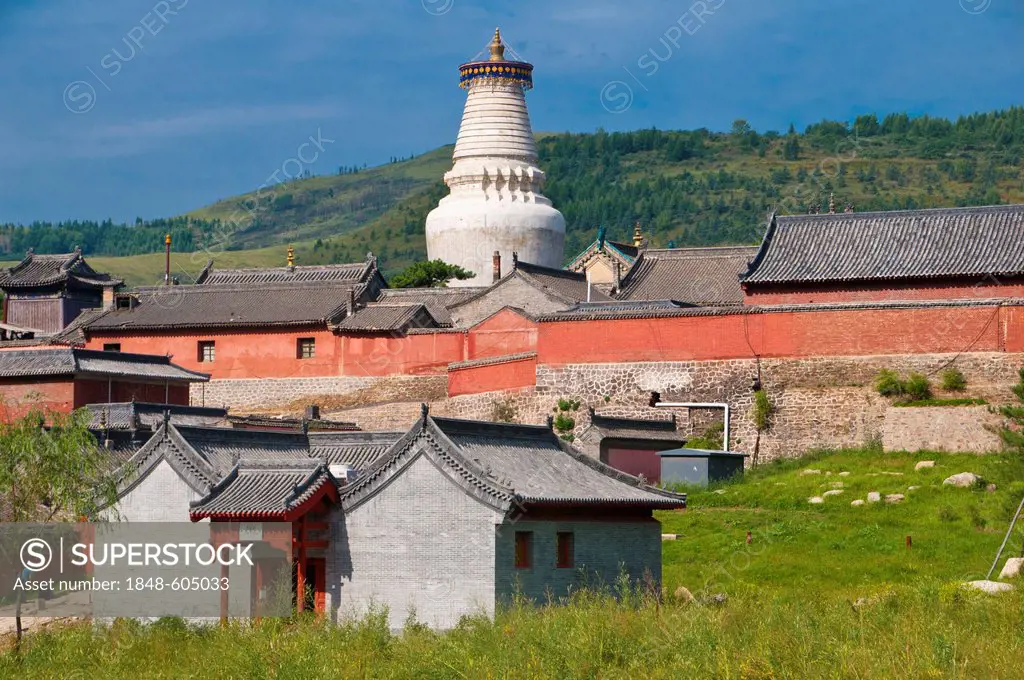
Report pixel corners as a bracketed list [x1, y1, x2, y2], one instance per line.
[327, 408, 686, 628]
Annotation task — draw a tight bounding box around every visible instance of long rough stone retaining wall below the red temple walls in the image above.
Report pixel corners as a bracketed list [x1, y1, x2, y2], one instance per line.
[194, 352, 1024, 461]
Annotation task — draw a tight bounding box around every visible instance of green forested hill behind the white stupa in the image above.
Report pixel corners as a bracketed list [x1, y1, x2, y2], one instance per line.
[0, 108, 1024, 278]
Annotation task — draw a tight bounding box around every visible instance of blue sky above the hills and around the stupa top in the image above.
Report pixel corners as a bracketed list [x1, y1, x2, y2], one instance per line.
[0, 0, 1024, 222]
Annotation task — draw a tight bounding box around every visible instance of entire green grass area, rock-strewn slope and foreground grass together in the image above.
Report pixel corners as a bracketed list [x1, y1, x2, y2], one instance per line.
[0, 450, 1024, 680]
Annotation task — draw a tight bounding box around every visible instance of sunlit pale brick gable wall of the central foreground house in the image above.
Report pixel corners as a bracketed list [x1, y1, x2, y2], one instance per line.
[327, 448, 502, 629]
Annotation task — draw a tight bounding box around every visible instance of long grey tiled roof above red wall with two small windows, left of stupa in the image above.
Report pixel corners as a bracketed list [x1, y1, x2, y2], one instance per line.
[86, 283, 353, 332]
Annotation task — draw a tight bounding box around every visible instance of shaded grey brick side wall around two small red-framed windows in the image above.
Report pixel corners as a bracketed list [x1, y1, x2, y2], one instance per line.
[495, 517, 662, 603]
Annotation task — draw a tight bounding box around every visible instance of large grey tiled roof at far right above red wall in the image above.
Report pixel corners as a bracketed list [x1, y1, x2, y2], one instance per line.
[743, 205, 1024, 284]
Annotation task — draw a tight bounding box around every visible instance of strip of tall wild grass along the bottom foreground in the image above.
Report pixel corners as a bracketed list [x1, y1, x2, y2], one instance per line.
[0, 583, 1024, 680]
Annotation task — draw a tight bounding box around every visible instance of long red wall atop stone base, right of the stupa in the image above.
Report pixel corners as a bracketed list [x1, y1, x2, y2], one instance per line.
[538, 306, 1011, 365]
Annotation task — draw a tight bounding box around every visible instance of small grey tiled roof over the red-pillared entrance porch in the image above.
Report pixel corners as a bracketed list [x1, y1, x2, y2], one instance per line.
[189, 459, 337, 520]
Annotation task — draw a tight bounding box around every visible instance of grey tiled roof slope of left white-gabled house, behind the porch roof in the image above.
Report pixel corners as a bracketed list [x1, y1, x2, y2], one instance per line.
[174, 425, 310, 475]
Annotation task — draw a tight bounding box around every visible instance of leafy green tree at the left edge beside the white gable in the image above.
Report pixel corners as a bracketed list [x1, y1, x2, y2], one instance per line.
[0, 409, 118, 640]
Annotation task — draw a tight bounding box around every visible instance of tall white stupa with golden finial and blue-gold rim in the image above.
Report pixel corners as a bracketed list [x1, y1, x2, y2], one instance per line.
[427, 31, 565, 286]
